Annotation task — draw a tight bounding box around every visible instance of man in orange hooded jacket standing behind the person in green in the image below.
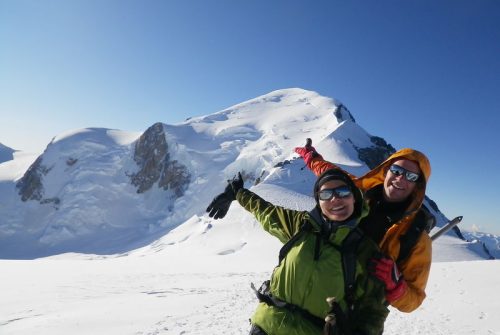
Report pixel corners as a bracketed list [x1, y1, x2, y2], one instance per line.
[295, 139, 432, 312]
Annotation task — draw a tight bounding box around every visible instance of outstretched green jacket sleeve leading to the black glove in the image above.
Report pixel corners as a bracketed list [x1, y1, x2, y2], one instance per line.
[236, 189, 306, 243]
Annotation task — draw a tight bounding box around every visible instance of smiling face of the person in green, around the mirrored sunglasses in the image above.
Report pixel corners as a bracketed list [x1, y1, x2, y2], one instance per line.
[319, 180, 354, 221]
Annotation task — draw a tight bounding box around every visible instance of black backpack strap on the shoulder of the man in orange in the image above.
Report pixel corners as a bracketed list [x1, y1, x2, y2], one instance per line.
[396, 205, 436, 264]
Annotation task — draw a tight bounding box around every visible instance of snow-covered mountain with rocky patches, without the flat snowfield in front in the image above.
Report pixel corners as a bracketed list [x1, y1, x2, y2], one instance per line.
[0, 89, 498, 258]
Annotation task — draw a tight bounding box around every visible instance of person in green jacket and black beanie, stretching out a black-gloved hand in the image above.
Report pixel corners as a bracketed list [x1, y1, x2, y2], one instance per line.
[207, 169, 389, 335]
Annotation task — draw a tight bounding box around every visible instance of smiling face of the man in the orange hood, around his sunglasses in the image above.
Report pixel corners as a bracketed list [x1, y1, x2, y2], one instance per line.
[384, 159, 421, 202]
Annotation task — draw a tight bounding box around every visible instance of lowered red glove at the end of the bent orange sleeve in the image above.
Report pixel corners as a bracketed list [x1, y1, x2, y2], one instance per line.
[370, 257, 408, 302]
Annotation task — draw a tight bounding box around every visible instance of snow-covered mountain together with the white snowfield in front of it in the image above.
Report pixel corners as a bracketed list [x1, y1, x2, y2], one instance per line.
[0, 89, 500, 335]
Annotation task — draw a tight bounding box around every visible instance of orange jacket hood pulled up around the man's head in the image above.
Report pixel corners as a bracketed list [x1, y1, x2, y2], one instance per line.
[354, 148, 431, 214]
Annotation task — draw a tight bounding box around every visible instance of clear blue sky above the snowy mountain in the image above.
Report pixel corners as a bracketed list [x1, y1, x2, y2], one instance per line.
[0, 0, 500, 234]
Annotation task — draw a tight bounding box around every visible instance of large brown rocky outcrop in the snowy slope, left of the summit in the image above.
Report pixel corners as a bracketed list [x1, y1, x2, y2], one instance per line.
[131, 123, 191, 197]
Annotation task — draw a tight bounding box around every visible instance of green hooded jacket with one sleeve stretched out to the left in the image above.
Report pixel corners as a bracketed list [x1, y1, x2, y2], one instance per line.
[236, 189, 389, 335]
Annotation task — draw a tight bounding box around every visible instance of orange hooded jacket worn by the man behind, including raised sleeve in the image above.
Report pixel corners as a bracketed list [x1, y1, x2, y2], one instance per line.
[307, 148, 432, 312]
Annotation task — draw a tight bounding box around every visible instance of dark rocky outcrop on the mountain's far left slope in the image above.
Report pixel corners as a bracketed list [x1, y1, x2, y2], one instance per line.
[16, 156, 50, 201]
